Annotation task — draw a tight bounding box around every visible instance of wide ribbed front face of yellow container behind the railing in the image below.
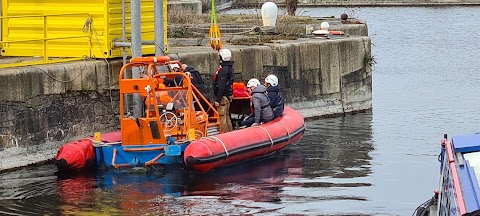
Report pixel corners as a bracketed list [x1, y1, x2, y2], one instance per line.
[2, 0, 103, 57]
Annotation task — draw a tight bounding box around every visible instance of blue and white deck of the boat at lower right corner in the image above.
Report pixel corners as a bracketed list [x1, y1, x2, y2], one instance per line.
[452, 134, 480, 212]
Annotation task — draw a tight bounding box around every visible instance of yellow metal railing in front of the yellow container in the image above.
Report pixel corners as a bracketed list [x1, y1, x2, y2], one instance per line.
[0, 13, 92, 68]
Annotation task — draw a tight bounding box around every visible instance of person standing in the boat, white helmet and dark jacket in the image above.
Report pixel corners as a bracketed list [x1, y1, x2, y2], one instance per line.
[213, 49, 233, 133]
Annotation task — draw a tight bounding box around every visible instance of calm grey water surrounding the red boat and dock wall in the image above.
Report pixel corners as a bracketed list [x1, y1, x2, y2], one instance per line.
[0, 7, 480, 215]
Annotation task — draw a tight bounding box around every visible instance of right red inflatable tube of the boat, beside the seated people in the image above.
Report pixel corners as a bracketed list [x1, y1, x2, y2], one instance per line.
[184, 107, 305, 172]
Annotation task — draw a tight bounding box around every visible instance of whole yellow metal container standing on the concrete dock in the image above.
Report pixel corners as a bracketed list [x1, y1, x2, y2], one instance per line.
[1, 0, 155, 58]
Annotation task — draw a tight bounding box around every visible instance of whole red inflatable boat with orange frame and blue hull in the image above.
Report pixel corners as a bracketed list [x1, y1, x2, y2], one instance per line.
[55, 56, 305, 172]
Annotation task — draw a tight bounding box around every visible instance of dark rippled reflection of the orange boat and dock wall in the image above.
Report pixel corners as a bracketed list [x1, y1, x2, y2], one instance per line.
[0, 113, 373, 215]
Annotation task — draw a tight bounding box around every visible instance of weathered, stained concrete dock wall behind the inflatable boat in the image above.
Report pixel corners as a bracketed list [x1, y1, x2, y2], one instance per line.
[0, 36, 372, 171]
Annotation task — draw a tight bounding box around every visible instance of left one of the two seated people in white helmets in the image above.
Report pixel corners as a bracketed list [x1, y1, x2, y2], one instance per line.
[241, 78, 273, 127]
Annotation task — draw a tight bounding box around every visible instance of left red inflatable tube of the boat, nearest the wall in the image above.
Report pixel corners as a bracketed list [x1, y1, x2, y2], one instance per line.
[55, 131, 122, 171]
